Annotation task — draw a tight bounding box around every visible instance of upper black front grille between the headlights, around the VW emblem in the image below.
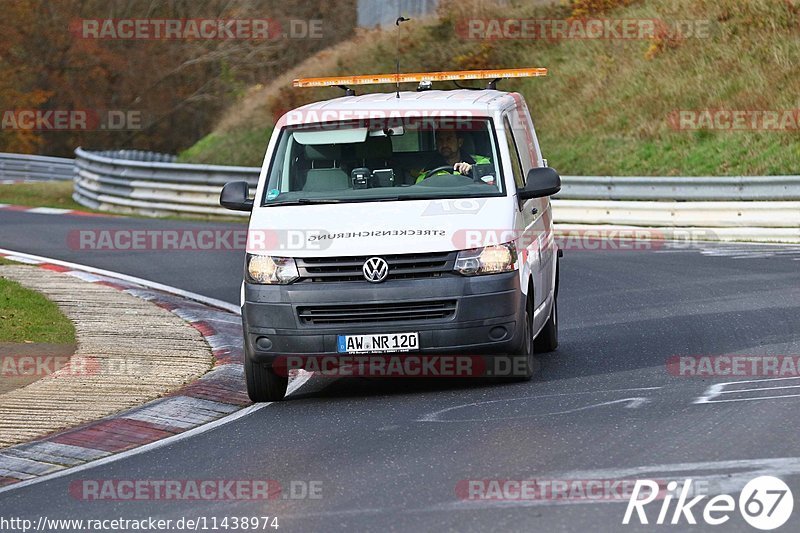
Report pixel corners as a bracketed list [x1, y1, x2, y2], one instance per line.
[297, 252, 457, 283]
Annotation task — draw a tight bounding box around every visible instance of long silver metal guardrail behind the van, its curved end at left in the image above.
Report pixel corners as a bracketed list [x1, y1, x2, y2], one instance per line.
[73, 148, 800, 239]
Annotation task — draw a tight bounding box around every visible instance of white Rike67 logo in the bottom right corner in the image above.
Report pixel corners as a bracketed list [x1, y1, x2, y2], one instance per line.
[622, 476, 794, 531]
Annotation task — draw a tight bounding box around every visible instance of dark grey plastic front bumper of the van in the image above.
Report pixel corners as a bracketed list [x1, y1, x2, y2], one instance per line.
[242, 272, 525, 364]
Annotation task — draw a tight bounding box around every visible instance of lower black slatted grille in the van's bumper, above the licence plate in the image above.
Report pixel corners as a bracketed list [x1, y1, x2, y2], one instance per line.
[297, 300, 456, 325]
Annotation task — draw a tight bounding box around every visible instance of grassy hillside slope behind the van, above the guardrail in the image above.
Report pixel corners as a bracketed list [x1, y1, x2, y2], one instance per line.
[182, 0, 800, 176]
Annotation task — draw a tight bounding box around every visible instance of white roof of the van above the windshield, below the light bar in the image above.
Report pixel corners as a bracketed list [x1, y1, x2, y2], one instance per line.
[290, 89, 514, 116]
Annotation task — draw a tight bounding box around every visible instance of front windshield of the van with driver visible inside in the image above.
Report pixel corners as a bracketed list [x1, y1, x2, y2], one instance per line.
[262, 118, 505, 206]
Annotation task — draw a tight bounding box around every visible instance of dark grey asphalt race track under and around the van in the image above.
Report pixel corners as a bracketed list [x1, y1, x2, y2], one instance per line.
[0, 212, 800, 531]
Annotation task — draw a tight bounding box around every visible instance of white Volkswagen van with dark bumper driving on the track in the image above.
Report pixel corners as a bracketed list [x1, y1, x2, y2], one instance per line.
[220, 71, 561, 402]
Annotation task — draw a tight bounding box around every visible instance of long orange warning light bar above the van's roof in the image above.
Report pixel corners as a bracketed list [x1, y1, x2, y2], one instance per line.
[292, 68, 547, 87]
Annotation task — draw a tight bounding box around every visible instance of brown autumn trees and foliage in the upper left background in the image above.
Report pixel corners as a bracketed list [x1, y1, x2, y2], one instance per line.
[0, 0, 356, 156]
